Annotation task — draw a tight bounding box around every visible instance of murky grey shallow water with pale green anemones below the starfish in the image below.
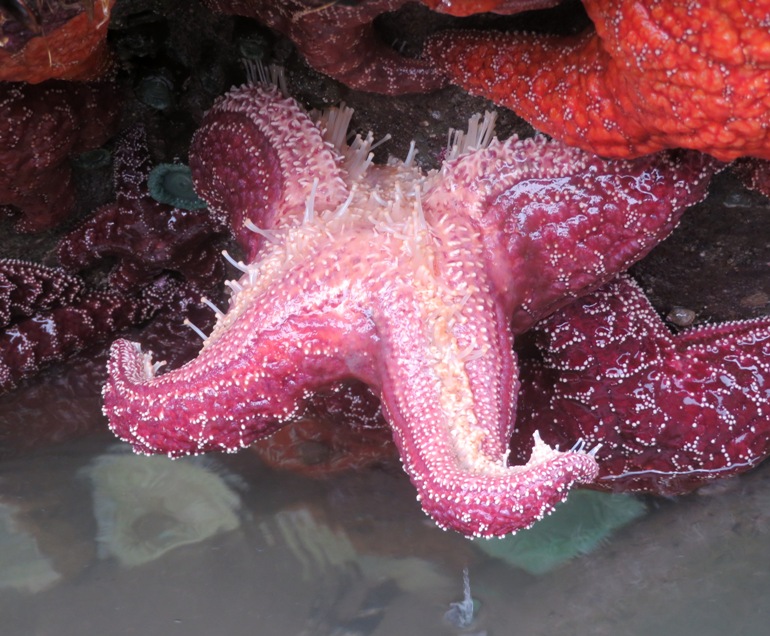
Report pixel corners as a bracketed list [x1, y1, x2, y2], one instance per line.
[0, 370, 770, 636]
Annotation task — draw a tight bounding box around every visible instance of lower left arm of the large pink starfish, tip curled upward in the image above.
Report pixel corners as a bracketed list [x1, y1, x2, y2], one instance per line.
[104, 247, 380, 456]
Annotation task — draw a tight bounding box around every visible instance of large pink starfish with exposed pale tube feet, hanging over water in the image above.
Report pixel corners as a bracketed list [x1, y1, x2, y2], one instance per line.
[104, 86, 718, 536]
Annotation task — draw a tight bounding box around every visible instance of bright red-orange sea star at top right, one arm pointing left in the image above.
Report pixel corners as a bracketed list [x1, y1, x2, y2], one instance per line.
[425, 0, 770, 161]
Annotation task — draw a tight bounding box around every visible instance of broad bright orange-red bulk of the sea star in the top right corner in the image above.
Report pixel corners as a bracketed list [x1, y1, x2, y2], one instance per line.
[577, 0, 770, 161]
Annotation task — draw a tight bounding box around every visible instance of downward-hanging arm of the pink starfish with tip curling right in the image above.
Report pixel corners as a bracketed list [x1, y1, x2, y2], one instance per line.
[368, 276, 597, 537]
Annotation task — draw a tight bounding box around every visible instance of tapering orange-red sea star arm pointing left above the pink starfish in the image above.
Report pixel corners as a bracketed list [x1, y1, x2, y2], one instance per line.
[424, 31, 636, 157]
